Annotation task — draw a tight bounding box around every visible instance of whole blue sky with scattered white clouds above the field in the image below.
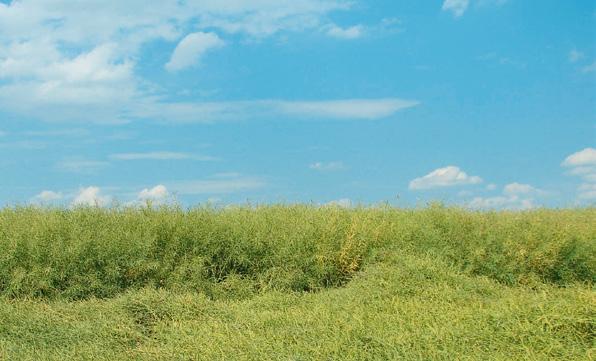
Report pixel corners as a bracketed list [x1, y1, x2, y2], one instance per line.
[0, 0, 596, 209]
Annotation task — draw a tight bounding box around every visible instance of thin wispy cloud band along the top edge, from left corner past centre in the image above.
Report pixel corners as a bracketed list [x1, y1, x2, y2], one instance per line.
[0, 0, 350, 44]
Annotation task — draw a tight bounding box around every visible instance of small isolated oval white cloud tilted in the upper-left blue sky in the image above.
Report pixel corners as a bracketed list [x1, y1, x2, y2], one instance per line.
[165, 32, 224, 72]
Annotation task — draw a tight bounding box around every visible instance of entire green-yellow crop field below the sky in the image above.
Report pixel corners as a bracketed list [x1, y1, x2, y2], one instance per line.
[0, 204, 596, 360]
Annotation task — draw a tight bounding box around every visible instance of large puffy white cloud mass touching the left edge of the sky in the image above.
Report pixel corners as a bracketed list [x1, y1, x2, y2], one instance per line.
[0, 41, 138, 122]
